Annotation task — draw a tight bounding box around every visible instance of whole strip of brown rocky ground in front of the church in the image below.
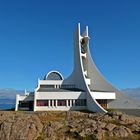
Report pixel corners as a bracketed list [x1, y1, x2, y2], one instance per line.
[0, 111, 140, 140]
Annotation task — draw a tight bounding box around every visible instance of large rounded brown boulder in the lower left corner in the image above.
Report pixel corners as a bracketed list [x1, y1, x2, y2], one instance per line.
[0, 112, 43, 140]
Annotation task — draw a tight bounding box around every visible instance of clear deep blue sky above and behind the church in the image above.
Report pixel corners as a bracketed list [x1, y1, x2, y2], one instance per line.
[0, 0, 140, 90]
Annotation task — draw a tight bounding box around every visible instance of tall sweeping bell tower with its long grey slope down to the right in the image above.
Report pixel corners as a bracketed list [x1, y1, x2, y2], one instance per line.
[64, 24, 140, 112]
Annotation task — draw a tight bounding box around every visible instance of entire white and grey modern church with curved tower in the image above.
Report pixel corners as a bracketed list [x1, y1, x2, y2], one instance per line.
[15, 24, 139, 112]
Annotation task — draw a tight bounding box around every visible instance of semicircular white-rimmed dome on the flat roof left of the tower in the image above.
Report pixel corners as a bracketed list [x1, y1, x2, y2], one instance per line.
[44, 71, 64, 80]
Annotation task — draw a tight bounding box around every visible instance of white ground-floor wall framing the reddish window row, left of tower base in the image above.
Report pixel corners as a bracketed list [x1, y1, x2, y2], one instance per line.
[34, 92, 86, 111]
